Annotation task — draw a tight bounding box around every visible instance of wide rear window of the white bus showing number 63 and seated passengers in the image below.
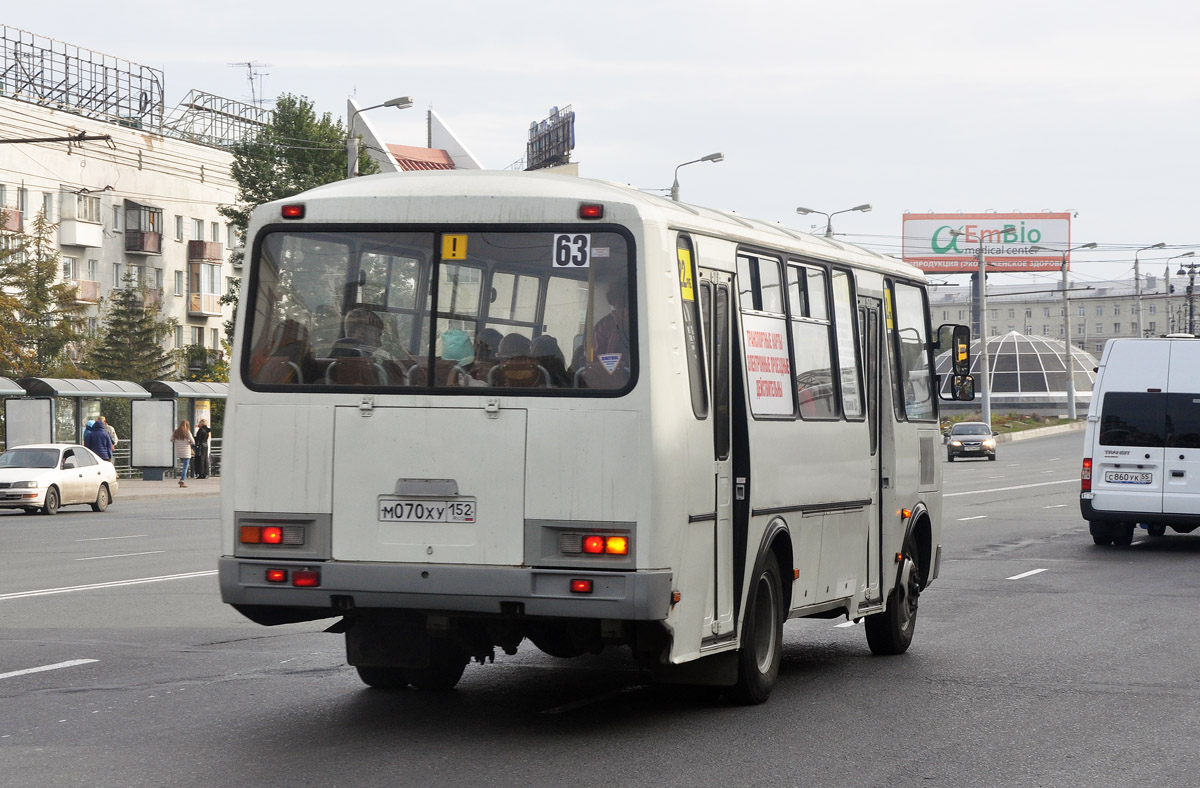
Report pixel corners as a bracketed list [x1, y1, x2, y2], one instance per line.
[242, 227, 636, 393]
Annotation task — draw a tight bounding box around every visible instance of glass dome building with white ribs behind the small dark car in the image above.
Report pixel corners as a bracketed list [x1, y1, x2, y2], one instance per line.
[936, 331, 1099, 415]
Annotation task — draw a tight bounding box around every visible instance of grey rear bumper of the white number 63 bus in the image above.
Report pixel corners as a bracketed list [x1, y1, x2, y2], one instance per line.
[217, 557, 672, 624]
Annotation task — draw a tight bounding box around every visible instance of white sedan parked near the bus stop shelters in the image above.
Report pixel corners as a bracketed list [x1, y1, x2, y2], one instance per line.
[0, 444, 118, 515]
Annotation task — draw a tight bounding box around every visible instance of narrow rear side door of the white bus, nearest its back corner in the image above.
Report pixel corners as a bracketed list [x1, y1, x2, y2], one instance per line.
[698, 269, 734, 638]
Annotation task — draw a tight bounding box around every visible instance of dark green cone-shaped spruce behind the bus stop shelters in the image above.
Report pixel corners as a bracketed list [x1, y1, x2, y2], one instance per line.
[89, 266, 178, 383]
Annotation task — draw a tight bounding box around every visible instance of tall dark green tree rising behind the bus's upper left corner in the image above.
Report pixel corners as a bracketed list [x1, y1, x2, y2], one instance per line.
[217, 94, 379, 345]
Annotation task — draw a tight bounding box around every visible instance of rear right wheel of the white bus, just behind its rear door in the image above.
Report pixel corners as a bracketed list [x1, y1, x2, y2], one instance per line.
[727, 553, 785, 705]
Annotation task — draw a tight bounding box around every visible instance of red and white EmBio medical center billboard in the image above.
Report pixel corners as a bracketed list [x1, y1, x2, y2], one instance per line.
[904, 212, 1070, 273]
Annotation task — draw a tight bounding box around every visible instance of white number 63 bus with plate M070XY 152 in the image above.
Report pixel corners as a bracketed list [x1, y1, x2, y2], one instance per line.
[220, 172, 973, 703]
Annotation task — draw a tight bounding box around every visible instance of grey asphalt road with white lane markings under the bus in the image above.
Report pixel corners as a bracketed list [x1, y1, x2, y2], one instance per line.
[0, 433, 1200, 788]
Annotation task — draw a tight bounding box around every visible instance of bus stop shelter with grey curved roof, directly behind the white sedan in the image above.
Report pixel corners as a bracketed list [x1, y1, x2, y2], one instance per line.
[5, 378, 150, 447]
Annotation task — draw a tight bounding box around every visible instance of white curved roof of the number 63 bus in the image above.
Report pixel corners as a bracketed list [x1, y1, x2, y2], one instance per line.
[254, 170, 925, 279]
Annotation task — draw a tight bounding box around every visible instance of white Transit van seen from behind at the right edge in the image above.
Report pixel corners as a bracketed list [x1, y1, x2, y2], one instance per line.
[1079, 337, 1200, 546]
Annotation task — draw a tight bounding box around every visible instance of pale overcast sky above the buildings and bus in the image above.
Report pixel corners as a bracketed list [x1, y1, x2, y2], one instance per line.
[9, 0, 1200, 289]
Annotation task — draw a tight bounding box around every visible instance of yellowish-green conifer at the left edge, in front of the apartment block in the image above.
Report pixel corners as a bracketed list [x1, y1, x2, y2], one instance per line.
[0, 211, 88, 378]
